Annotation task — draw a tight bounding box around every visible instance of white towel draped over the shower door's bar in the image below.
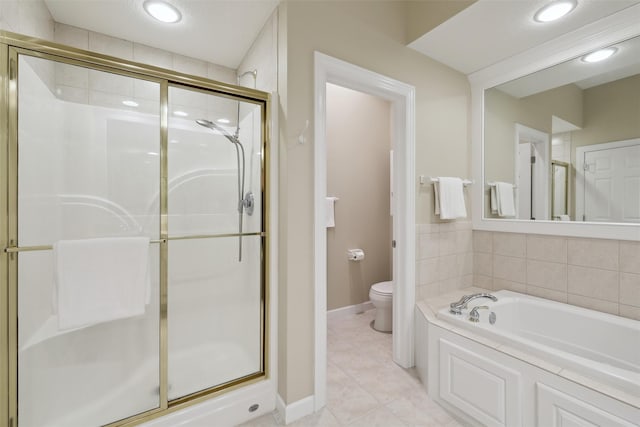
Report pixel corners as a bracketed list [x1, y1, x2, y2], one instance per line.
[53, 237, 150, 330]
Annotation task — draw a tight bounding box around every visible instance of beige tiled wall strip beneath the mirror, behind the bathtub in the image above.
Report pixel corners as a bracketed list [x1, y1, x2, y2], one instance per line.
[473, 230, 640, 319]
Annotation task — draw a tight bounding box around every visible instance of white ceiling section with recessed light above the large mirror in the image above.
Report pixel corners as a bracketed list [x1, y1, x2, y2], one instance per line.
[409, 0, 640, 74]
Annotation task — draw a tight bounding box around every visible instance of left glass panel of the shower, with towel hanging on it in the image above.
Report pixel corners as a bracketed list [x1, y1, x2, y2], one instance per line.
[17, 55, 160, 427]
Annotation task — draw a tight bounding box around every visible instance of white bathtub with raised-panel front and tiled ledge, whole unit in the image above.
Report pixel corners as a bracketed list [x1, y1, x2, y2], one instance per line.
[415, 288, 640, 427]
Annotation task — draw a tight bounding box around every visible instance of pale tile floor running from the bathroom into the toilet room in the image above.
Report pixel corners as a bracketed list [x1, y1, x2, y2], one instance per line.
[242, 310, 462, 427]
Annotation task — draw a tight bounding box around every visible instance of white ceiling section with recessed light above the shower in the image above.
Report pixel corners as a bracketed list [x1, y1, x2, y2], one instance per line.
[45, 0, 278, 69]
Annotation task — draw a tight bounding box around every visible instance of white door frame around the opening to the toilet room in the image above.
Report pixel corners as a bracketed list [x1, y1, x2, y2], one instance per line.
[314, 52, 416, 411]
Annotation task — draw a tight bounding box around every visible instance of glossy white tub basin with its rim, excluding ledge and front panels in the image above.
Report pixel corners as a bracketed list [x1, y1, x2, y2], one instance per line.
[437, 291, 640, 396]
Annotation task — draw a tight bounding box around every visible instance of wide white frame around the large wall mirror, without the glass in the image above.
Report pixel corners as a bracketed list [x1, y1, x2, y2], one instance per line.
[468, 4, 640, 241]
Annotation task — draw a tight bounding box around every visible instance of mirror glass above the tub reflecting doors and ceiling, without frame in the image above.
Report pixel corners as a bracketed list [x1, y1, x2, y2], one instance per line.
[484, 37, 640, 223]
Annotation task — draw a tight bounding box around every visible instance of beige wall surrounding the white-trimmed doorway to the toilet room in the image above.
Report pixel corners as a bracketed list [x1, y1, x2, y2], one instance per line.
[279, 1, 470, 403]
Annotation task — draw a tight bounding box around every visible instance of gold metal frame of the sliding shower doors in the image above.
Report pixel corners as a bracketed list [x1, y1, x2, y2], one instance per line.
[0, 31, 271, 427]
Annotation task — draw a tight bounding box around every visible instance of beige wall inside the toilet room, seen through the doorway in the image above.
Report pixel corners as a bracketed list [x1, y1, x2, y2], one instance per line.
[326, 84, 392, 310]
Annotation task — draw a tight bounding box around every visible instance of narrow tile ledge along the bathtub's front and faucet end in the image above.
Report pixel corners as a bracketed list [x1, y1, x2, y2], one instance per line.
[416, 286, 640, 408]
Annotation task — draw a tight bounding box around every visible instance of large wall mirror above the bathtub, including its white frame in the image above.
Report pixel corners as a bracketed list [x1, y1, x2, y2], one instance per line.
[469, 8, 640, 240]
